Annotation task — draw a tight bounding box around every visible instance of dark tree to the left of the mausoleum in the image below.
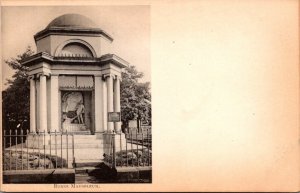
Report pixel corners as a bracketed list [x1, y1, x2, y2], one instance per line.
[2, 47, 34, 133]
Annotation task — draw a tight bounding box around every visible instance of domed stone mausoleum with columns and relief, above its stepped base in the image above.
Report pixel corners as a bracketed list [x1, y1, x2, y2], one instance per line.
[23, 14, 128, 149]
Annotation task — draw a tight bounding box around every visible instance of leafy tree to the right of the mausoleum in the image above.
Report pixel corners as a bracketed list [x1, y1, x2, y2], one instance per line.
[121, 66, 151, 127]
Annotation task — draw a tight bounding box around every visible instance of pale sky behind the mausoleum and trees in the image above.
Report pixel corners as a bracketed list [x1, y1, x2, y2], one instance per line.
[1, 5, 151, 89]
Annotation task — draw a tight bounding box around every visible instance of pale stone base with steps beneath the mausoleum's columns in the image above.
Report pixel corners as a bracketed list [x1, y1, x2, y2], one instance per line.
[26, 132, 136, 166]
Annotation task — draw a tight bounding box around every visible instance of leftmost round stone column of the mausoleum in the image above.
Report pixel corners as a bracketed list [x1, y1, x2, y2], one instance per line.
[29, 76, 36, 133]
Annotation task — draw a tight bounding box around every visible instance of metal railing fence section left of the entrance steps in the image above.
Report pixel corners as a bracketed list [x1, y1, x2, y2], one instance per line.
[2, 130, 75, 171]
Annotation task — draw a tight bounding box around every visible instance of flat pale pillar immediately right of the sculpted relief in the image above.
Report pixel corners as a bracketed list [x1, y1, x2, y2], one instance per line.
[94, 75, 103, 133]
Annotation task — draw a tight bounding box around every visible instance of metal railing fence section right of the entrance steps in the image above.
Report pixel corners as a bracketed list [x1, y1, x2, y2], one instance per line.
[104, 128, 152, 168]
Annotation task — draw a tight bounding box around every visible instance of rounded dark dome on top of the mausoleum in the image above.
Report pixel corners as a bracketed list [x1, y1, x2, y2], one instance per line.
[47, 14, 97, 29]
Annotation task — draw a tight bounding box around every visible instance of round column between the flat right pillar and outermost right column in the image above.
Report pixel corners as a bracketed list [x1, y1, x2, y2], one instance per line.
[106, 74, 114, 132]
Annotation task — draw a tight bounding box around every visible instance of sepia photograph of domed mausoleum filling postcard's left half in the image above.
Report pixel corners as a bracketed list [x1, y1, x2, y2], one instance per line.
[1, 6, 152, 184]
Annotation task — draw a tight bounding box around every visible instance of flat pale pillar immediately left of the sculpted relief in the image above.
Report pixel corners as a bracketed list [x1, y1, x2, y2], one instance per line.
[50, 75, 59, 132]
